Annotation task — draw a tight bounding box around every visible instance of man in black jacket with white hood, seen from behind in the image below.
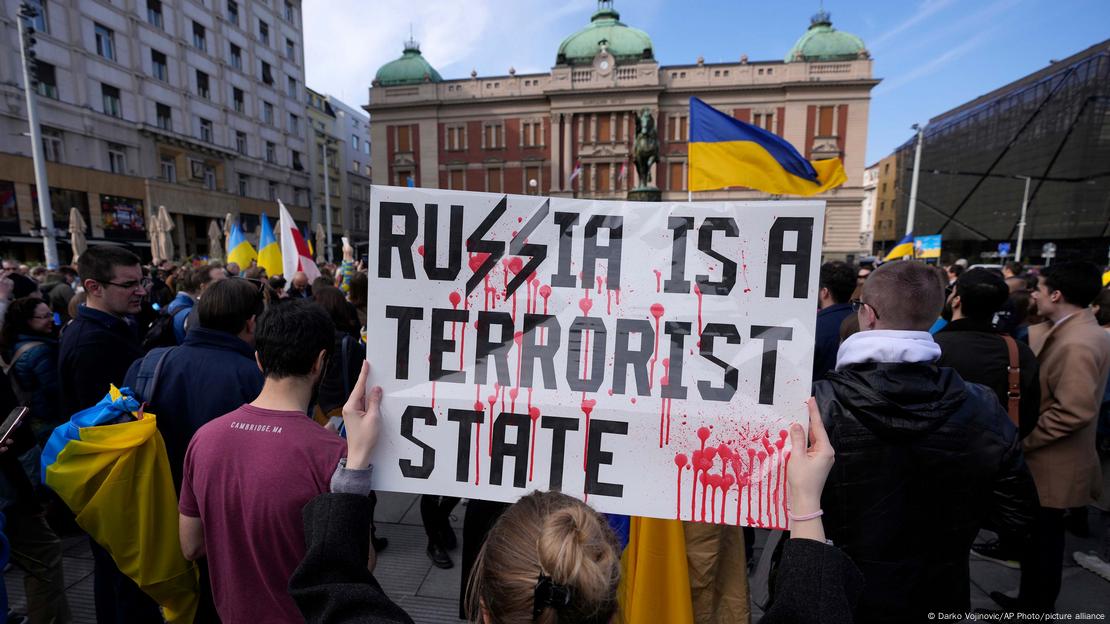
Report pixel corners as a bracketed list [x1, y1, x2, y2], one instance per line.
[814, 262, 1037, 622]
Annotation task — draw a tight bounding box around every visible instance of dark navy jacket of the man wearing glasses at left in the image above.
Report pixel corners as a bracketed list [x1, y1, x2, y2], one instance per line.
[58, 305, 142, 420]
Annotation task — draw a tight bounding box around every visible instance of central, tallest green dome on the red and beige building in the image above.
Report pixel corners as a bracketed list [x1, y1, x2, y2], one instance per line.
[555, 0, 654, 66]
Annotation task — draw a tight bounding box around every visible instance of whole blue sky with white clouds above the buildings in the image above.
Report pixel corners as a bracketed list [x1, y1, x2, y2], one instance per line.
[304, 0, 1110, 163]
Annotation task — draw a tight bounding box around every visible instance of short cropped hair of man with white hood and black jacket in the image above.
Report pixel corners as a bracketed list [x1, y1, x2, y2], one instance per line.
[862, 260, 945, 331]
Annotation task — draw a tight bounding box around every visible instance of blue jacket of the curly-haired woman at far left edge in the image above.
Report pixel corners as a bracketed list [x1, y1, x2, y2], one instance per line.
[10, 334, 61, 442]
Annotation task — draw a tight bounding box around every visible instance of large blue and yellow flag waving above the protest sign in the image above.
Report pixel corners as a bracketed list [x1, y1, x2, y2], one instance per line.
[688, 98, 848, 195]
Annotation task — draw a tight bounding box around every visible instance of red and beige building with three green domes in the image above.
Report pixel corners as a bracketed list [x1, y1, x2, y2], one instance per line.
[365, 0, 878, 259]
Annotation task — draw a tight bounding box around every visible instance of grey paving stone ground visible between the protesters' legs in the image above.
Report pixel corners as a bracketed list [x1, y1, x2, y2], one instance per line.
[4, 492, 1110, 624]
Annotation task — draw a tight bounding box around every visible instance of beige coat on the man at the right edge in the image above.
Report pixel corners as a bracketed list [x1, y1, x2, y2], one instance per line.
[1025, 310, 1110, 509]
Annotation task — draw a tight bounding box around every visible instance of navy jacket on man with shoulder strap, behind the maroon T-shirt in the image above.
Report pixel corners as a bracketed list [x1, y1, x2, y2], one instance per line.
[123, 328, 263, 491]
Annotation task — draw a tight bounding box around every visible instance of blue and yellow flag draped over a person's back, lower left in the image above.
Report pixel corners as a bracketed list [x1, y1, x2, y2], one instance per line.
[42, 385, 199, 623]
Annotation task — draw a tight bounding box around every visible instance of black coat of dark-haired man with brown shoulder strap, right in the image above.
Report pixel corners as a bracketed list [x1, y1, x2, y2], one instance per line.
[932, 319, 1040, 437]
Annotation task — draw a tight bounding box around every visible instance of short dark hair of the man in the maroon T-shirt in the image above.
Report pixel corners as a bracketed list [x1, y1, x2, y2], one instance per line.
[254, 300, 335, 379]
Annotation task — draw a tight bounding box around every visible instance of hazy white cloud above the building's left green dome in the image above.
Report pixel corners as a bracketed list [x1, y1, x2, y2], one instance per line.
[303, 0, 596, 107]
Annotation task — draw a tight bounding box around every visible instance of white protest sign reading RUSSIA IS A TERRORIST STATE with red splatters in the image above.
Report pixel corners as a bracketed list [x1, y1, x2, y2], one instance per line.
[366, 187, 825, 527]
